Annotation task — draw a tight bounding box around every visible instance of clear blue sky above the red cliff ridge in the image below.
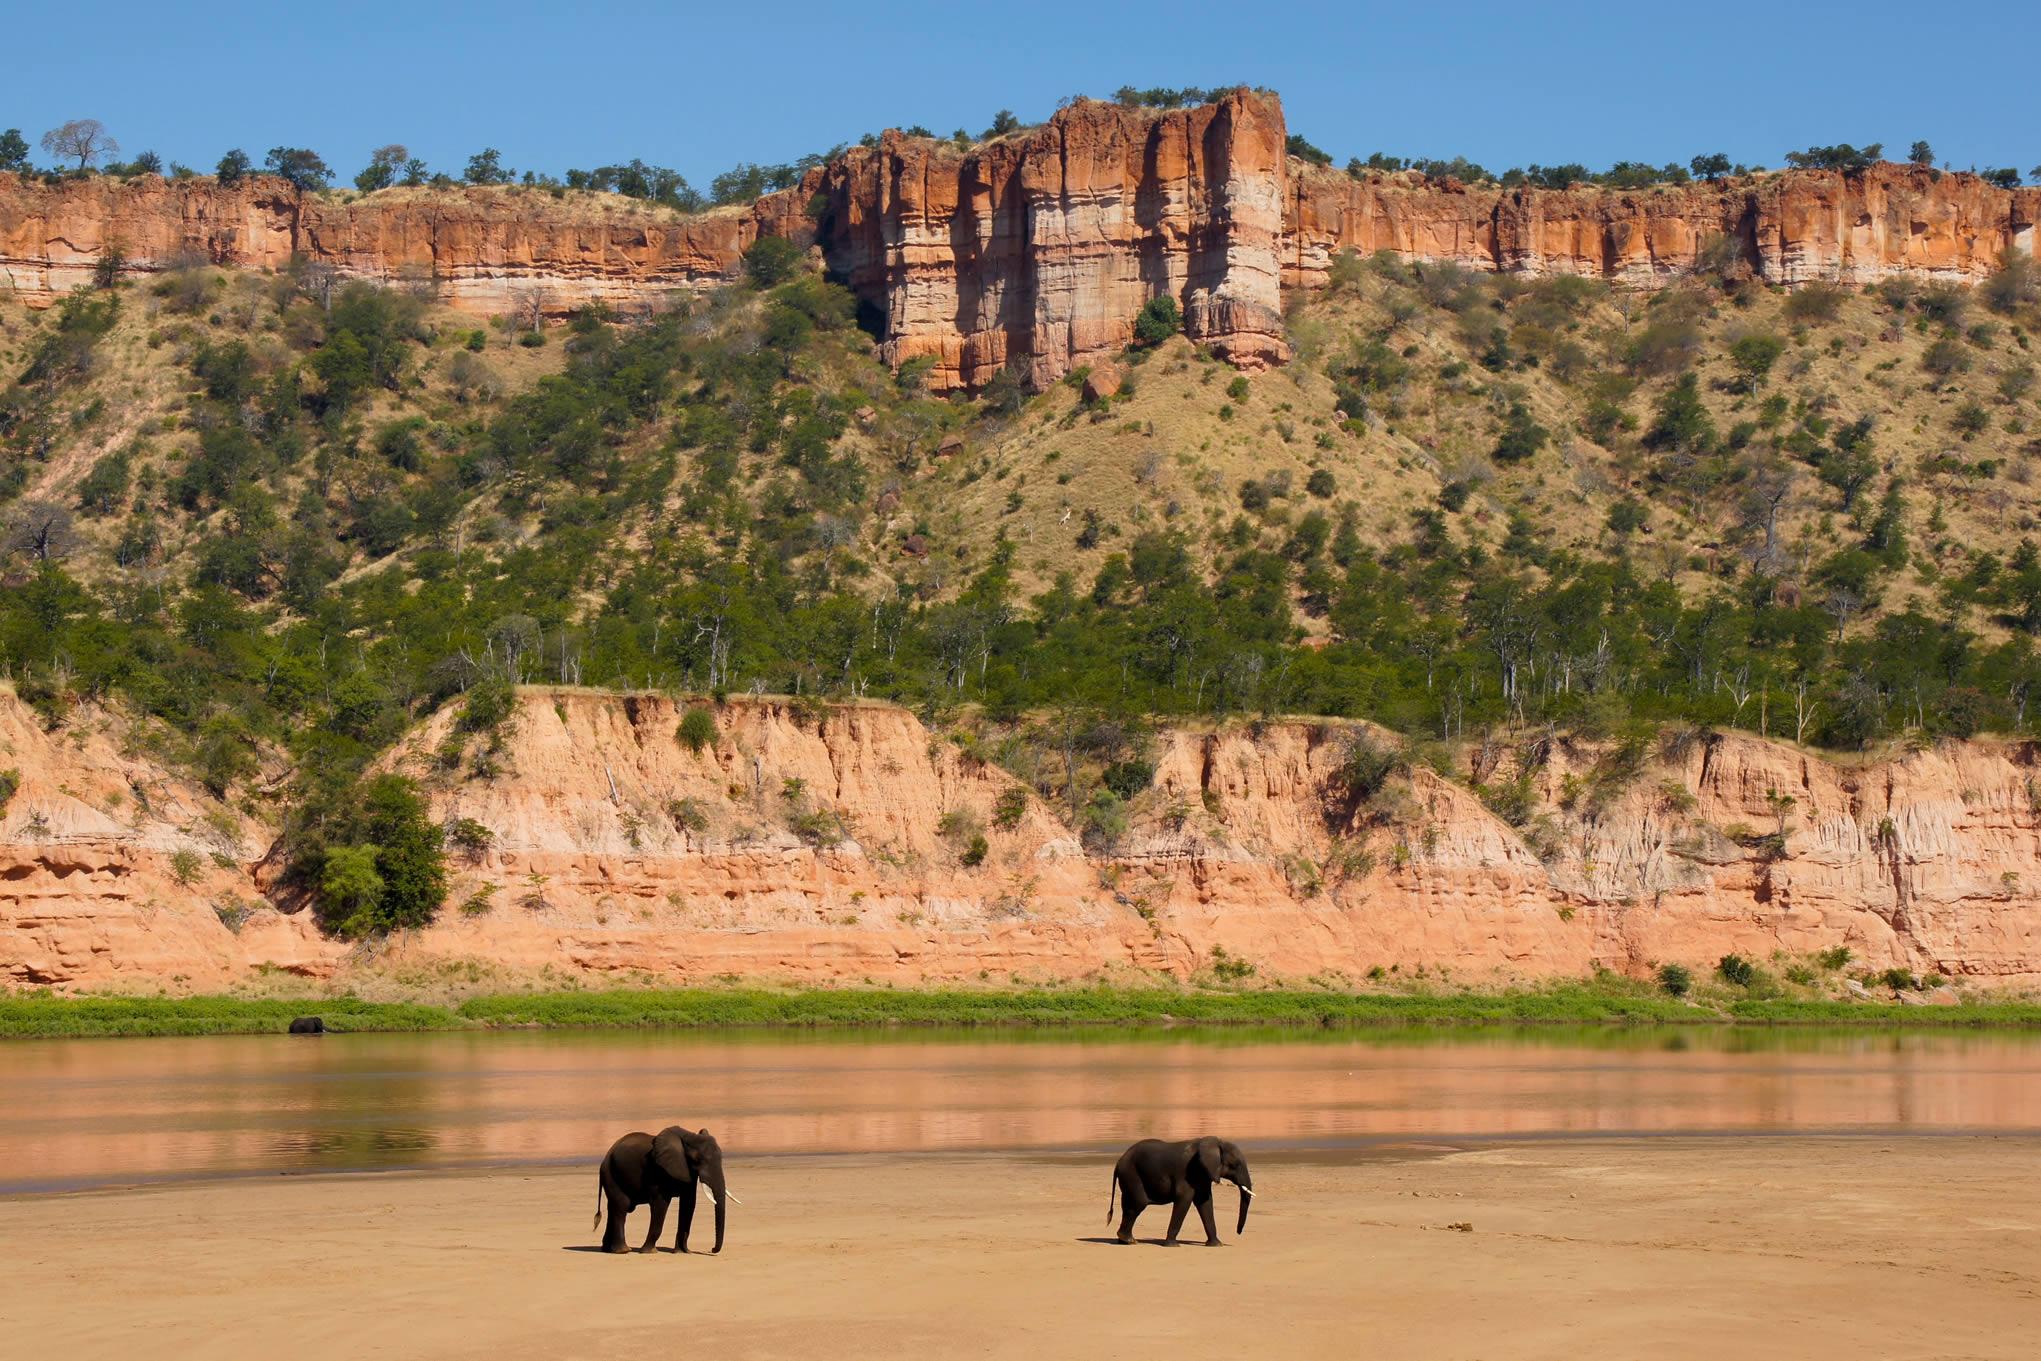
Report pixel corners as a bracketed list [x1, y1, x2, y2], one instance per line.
[15, 0, 2041, 188]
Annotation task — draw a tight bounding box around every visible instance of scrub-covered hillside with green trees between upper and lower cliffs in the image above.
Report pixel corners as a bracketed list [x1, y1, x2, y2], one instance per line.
[0, 109, 2041, 979]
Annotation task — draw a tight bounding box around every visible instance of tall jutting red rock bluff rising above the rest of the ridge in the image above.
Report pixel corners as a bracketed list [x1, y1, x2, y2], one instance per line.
[812, 90, 1288, 390]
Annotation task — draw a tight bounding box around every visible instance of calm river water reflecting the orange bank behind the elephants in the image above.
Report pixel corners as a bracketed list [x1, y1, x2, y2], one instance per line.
[0, 1030, 2041, 1192]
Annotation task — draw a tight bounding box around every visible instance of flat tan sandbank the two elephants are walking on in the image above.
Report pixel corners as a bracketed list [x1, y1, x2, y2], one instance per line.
[0, 1137, 2041, 1361]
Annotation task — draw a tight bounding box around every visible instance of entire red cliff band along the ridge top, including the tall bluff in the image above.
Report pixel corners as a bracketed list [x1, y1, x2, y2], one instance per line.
[0, 90, 2041, 392]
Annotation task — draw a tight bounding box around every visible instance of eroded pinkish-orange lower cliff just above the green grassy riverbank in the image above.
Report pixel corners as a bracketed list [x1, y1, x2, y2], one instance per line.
[0, 692, 2041, 988]
